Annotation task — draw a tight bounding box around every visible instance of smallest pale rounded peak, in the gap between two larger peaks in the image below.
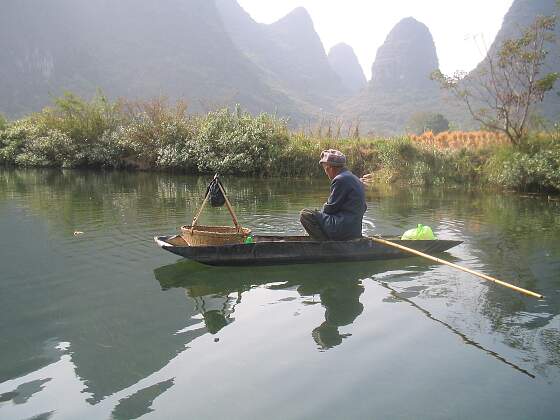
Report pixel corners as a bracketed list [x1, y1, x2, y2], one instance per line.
[328, 43, 367, 94]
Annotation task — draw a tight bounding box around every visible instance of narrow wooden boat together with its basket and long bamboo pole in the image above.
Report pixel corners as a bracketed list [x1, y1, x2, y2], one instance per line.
[154, 174, 544, 299]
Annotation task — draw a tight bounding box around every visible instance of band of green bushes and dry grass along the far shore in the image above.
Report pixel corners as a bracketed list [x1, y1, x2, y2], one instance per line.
[0, 94, 560, 192]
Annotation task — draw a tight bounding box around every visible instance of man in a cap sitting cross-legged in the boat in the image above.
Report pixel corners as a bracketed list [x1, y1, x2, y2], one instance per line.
[300, 149, 367, 241]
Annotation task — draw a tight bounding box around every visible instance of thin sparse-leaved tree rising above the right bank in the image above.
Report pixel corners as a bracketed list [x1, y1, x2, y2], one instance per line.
[432, 16, 560, 145]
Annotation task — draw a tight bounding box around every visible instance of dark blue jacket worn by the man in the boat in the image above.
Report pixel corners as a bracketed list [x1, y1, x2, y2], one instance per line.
[316, 169, 367, 241]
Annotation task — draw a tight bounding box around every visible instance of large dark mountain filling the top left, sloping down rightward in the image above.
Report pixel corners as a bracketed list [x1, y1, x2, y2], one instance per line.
[0, 0, 302, 118]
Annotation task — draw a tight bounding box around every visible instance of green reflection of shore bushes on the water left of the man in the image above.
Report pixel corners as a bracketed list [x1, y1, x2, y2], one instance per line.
[0, 168, 328, 233]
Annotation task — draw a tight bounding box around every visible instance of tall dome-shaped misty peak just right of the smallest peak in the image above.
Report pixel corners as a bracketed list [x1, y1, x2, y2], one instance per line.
[342, 18, 464, 134]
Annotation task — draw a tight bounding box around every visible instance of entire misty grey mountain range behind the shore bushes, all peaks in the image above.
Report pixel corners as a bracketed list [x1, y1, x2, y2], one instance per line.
[0, 0, 560, 134]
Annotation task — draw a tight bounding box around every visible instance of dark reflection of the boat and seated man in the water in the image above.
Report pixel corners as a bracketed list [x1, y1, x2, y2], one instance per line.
[154, 261, 430, 350]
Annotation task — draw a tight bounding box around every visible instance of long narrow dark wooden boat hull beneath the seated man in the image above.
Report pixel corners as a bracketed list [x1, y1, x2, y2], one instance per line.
[154, 235, 462, 266]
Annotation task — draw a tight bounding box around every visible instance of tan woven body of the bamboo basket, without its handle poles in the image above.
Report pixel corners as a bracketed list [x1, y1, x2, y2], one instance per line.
[181, 226, 251, 246]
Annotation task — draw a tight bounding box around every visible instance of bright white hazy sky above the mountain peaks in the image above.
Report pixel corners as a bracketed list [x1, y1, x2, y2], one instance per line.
[234, 0, 513, 79]
